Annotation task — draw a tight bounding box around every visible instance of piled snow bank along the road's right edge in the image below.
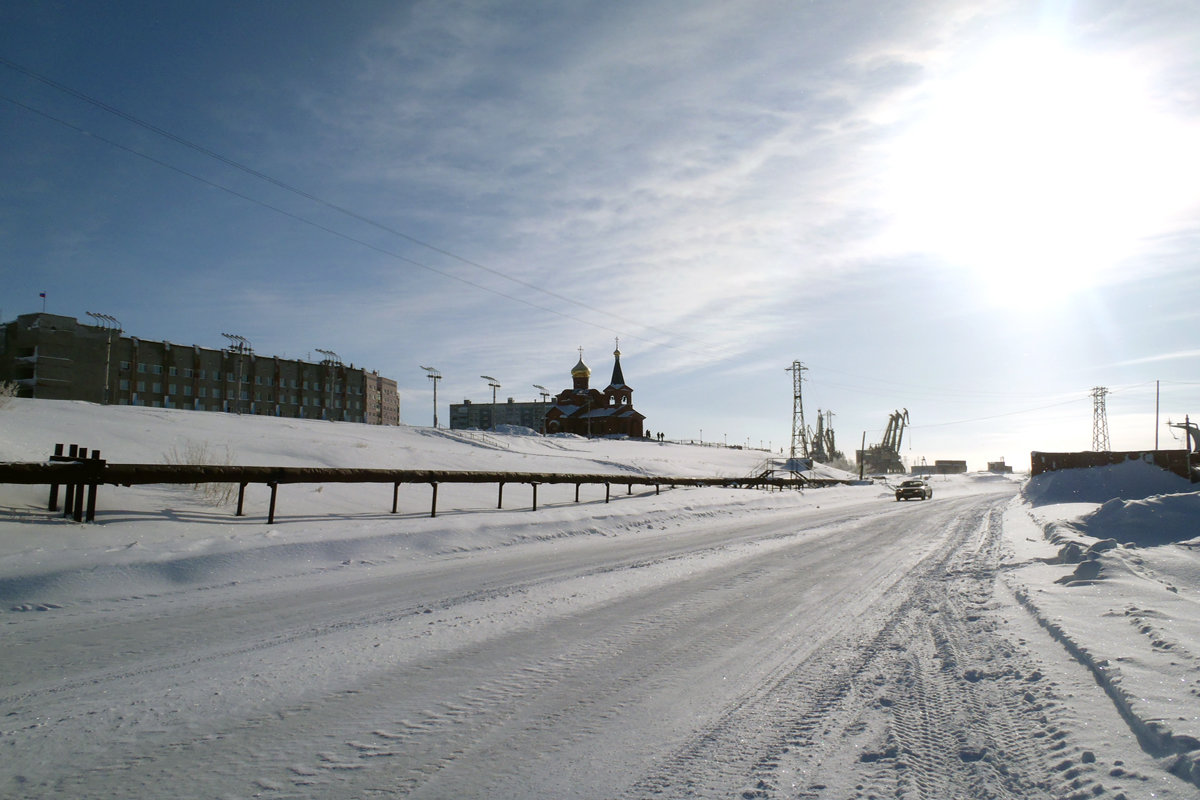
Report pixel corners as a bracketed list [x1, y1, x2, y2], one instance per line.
[1004, 461, 1200, 786]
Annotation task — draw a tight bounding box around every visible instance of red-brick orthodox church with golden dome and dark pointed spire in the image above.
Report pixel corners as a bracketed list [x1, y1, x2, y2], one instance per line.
[546, 342, 646, 438]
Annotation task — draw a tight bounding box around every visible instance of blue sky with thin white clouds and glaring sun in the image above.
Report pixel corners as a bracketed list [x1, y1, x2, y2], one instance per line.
[0, 0, 1200, 468]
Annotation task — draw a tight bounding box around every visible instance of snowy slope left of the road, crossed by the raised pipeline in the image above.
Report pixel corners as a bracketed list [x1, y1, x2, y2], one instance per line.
[0, 399, 854, 587]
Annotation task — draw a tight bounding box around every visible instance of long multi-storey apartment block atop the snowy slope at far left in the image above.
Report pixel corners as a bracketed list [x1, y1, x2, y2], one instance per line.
[0, 313, 400, 425]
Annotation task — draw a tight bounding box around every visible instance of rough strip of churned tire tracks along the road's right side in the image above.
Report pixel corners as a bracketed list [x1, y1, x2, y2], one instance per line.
[630, 504, 1123, 800]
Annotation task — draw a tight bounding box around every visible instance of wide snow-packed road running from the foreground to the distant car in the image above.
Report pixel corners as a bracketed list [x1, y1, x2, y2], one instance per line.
[0, 482, 1187, 798]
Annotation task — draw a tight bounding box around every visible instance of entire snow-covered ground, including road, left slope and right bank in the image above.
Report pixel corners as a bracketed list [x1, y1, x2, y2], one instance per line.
[0, 401, 1200, 799]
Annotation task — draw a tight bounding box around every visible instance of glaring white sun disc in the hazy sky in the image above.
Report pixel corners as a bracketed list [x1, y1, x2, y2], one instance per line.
[884, 34, 1200, 303]
